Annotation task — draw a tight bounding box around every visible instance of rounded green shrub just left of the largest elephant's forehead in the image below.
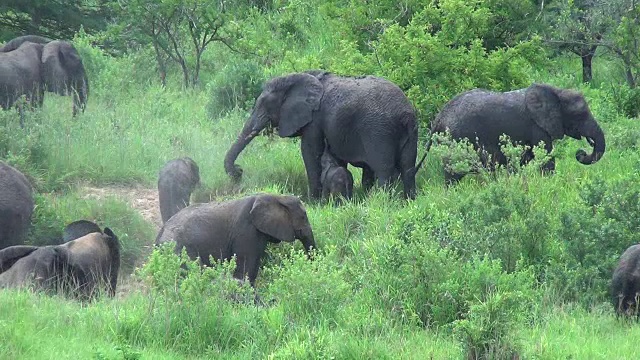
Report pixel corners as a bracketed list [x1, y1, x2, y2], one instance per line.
[207, 60, 264, 118]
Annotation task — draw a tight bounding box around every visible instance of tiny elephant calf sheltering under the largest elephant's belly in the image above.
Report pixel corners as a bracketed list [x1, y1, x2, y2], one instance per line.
[320, 148, 353, 202]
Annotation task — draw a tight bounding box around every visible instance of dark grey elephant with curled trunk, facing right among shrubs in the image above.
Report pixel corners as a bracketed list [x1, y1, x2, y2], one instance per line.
[431, 84, 605, 183]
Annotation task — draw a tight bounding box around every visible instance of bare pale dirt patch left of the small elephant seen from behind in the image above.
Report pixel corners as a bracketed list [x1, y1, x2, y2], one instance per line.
[81, 185, 162, 230]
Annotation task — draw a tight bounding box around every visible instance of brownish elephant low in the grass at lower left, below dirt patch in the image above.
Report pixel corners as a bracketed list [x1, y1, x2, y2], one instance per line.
[0, 228, 120, 299]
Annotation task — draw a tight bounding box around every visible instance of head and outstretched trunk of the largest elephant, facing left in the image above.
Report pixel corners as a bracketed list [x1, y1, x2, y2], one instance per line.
[224, 73, 324, 180]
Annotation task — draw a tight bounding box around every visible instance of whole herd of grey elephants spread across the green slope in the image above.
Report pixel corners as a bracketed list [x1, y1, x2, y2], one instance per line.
[0, 35, 640, 311]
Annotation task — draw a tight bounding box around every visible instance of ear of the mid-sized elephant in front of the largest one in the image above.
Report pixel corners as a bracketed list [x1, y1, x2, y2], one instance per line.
[249, 195, 295, 242]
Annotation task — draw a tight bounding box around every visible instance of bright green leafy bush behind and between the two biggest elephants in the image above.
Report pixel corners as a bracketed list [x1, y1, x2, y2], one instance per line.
[332, 0, 544, 123]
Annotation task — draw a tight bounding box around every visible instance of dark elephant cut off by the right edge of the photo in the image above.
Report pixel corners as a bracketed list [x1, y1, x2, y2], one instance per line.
[611, 244, 640, 317]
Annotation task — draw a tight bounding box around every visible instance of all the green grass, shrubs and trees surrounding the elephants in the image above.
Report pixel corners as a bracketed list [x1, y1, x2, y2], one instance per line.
[0, 0, 640, 359]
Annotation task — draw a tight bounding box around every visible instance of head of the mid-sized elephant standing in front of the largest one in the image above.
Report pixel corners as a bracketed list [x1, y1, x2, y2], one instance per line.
[249, 195, 316, 256]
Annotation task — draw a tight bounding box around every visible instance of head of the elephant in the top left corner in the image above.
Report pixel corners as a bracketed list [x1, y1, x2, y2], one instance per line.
[42, 40, 89, 116]
